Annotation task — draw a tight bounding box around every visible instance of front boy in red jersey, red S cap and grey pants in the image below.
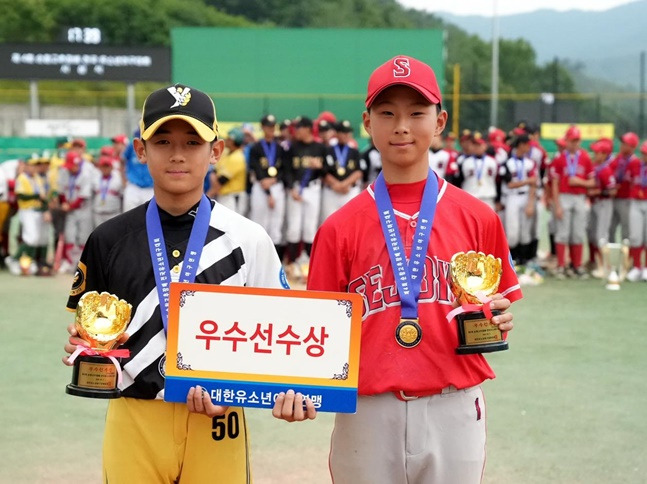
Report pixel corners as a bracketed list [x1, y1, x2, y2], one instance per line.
[308, 56, 521, 484]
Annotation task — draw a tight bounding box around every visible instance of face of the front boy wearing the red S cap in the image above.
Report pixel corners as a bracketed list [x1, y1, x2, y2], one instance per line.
[363, 85, 447, 168]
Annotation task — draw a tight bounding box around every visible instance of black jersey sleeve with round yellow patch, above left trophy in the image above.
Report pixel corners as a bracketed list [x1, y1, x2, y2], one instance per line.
[67, 232, 108, 311]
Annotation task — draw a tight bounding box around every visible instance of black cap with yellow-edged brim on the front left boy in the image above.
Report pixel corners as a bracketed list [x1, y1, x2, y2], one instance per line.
[139, 84, 218, 141]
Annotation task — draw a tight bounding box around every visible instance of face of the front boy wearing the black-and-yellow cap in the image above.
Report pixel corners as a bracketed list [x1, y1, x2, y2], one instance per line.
[134, 119, 224, 198]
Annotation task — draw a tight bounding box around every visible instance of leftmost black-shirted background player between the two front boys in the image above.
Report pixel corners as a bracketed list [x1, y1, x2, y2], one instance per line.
[249, 114, 285, 261]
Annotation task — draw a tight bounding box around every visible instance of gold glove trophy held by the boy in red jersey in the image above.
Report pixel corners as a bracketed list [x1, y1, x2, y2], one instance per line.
[447, 251, 508, 355]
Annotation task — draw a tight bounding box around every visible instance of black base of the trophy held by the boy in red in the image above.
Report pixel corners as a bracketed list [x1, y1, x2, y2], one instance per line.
[456, 309, 509, 355]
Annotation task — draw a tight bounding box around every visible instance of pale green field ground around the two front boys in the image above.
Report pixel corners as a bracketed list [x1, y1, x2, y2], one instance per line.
[0, 272, 647, 484]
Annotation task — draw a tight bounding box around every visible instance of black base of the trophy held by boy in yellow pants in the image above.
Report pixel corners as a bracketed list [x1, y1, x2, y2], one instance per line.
[65, 355, 121, 398]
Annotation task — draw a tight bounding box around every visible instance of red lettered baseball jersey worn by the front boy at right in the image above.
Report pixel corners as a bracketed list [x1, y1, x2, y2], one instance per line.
[308, 176, 522, 395]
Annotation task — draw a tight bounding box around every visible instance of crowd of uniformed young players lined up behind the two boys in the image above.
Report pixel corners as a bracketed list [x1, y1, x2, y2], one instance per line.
[0, 112, 647, 281]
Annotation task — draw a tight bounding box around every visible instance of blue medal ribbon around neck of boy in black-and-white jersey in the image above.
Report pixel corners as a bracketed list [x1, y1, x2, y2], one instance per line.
[146, 195, 211, 333]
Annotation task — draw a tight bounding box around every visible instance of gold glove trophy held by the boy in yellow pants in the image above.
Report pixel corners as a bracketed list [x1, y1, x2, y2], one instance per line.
[65, 291, 132, 398]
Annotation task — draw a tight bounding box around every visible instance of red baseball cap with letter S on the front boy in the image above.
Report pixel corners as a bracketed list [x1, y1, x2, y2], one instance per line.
[366, 55, 442, 108]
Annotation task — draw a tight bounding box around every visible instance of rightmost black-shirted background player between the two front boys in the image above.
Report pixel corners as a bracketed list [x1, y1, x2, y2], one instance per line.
[321, 120, 367, 221]
